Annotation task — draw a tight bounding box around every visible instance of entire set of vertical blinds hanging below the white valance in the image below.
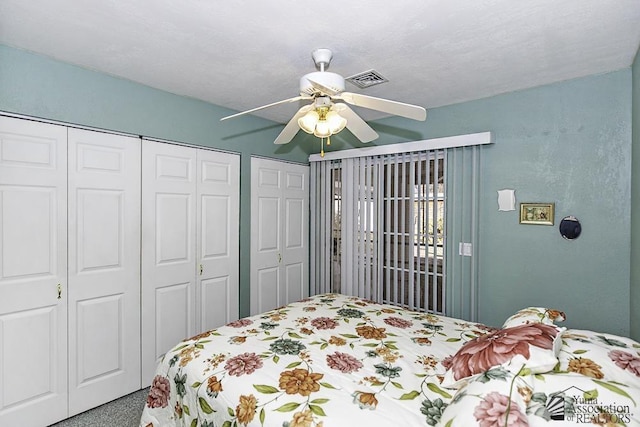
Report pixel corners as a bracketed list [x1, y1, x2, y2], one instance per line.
[310, 135, 480, 320]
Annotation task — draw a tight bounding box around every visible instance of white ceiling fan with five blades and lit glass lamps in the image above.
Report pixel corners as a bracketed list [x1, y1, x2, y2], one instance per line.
[220, 49, 427, 148]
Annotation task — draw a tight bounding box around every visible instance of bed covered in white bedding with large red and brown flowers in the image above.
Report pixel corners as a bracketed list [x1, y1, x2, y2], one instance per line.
[140, 294, 640, 427]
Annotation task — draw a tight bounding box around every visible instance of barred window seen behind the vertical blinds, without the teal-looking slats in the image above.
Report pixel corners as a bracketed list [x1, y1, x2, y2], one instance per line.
[314, 150, 445, 312]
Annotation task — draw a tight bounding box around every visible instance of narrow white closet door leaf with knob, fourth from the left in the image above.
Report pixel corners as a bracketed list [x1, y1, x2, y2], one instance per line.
[196, 149, 240, 333]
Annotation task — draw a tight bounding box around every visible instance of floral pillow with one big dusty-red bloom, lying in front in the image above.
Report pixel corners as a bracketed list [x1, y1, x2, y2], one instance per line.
[442, 323, 563, 388]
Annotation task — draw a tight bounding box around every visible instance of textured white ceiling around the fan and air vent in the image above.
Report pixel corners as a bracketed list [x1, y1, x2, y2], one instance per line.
[0, 0, 640, 123]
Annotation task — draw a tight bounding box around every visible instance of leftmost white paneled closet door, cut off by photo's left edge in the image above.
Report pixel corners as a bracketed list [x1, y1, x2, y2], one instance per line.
[0, 117, 68, 427]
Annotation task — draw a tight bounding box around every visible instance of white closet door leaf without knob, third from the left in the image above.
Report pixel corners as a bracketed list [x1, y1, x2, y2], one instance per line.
[142, 141, 197, 386]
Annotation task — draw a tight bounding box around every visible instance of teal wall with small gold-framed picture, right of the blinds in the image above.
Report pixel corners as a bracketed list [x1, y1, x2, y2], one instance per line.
[368, 69, 637, 335]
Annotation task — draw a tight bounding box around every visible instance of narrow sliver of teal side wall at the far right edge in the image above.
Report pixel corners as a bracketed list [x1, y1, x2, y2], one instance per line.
[630, 46, 640, 341]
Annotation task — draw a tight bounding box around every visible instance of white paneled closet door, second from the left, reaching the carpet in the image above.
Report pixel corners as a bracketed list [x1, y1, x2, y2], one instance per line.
[68, 129, 141, 416]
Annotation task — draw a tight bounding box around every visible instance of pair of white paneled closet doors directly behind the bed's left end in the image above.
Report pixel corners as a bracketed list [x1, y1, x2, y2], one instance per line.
[142, 141, 239, 385]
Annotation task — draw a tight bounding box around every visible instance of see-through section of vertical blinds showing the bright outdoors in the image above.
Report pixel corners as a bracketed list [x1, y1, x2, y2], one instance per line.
[382, 150, 445, 313]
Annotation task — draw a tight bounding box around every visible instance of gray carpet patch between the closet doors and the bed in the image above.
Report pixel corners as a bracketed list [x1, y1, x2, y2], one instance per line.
[51, 388, 149, 427]
